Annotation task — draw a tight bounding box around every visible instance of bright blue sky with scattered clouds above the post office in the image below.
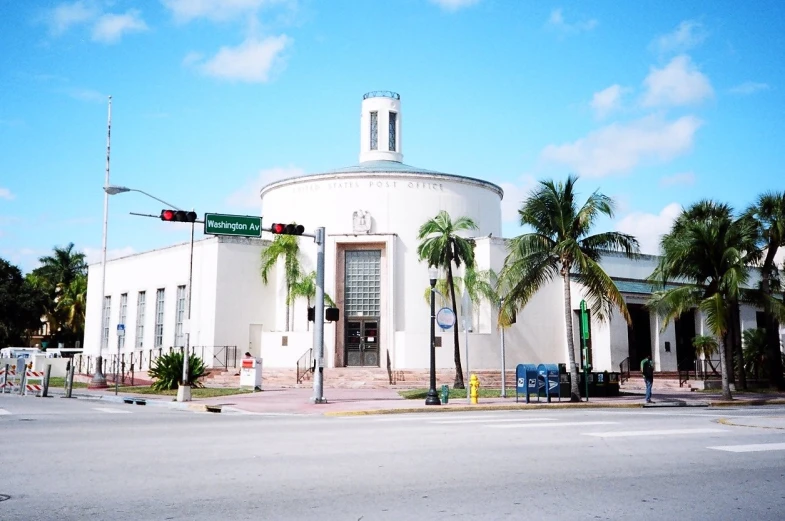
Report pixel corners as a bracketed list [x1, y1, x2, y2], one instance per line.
[0, 0, 785, 271]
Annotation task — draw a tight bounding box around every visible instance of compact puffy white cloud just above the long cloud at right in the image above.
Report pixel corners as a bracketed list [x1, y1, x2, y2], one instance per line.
[643, 55, 714, 107]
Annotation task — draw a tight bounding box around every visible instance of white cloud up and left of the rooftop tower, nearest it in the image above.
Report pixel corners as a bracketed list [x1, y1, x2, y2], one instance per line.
[191, 35, 292, 83]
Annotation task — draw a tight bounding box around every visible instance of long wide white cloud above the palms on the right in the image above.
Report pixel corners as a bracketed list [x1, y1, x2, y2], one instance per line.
[541, 116, 702, 177]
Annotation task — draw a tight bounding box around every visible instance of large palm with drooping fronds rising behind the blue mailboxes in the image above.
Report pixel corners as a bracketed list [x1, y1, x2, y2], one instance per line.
[499, 175, 639, 402]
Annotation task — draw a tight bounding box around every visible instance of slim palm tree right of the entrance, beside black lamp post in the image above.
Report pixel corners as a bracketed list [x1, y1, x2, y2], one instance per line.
[417, 210, 477, 389]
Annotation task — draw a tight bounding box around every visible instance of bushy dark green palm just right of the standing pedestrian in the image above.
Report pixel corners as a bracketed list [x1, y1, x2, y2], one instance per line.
[648, 200, 755, 400]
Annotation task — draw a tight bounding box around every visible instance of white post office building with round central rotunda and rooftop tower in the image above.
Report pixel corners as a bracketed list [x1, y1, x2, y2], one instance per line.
[85, 92, 776, 380]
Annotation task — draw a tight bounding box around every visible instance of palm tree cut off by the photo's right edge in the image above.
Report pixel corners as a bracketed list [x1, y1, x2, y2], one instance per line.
[745, 192, 785, 391]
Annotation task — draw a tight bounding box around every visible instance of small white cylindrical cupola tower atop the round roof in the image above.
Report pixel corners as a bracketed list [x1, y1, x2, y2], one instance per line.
[360, 91, 403, 163]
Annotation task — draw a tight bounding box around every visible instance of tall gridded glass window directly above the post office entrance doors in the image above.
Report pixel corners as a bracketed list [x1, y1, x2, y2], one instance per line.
[344, 250, 382, 317]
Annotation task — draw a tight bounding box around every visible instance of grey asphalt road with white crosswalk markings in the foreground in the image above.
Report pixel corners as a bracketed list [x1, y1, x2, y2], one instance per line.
[0, 395, 785, 521]
